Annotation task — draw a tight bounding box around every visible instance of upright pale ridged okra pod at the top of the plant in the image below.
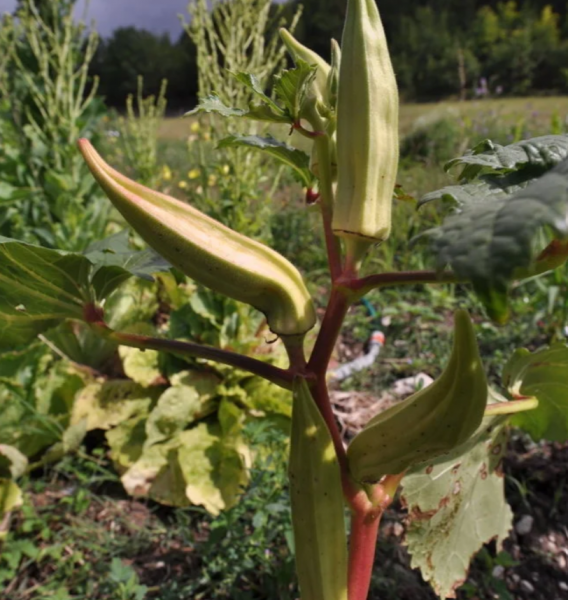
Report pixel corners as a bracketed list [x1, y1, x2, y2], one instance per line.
[332, 0, 399, 247]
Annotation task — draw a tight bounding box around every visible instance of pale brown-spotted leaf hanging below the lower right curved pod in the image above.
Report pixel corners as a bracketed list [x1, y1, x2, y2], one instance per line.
[401, 416, 513, 598]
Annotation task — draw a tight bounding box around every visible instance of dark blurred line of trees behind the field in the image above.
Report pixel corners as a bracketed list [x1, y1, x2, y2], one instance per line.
[30, 0, 568, 111]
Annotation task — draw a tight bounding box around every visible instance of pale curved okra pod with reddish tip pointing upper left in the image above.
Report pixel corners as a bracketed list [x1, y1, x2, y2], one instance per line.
[79, 140, 316, 336]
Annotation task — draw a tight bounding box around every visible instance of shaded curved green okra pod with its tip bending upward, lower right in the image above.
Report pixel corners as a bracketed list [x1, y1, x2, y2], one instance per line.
[347, 310, 487, 483]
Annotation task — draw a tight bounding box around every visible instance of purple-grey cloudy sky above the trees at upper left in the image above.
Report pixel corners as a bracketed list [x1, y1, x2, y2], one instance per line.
[0, 0, 197, 39]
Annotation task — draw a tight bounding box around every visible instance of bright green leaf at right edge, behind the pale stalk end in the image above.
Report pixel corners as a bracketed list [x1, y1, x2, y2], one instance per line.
[503, 343, 568, 442]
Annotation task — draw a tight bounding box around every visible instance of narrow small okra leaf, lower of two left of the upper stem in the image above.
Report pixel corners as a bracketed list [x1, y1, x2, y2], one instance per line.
[218, 135, 315, 187]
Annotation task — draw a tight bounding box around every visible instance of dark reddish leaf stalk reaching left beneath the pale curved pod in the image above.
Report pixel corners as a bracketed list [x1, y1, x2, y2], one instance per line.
[89, 321, 294, 390]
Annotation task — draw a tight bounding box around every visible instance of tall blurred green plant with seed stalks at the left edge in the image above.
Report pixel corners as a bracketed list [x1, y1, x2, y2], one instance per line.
[0, 0, 108, 250]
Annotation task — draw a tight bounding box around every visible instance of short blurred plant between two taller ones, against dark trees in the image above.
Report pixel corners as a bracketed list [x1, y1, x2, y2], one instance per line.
[118, 76, 167, 186]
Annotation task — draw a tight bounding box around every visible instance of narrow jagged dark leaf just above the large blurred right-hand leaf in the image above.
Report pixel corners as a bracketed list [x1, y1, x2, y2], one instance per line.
[445, 134, 568, 181]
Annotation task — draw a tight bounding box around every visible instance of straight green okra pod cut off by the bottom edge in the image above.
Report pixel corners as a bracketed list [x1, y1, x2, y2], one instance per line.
[288, 377, 348, 600]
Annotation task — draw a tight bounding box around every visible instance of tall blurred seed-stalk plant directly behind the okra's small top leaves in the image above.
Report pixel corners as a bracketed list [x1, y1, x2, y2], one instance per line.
[184, 0, 301, 241]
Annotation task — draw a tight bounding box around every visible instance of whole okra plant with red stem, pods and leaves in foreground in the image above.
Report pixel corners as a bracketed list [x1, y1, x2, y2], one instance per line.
[0, 0, 568, 600]
